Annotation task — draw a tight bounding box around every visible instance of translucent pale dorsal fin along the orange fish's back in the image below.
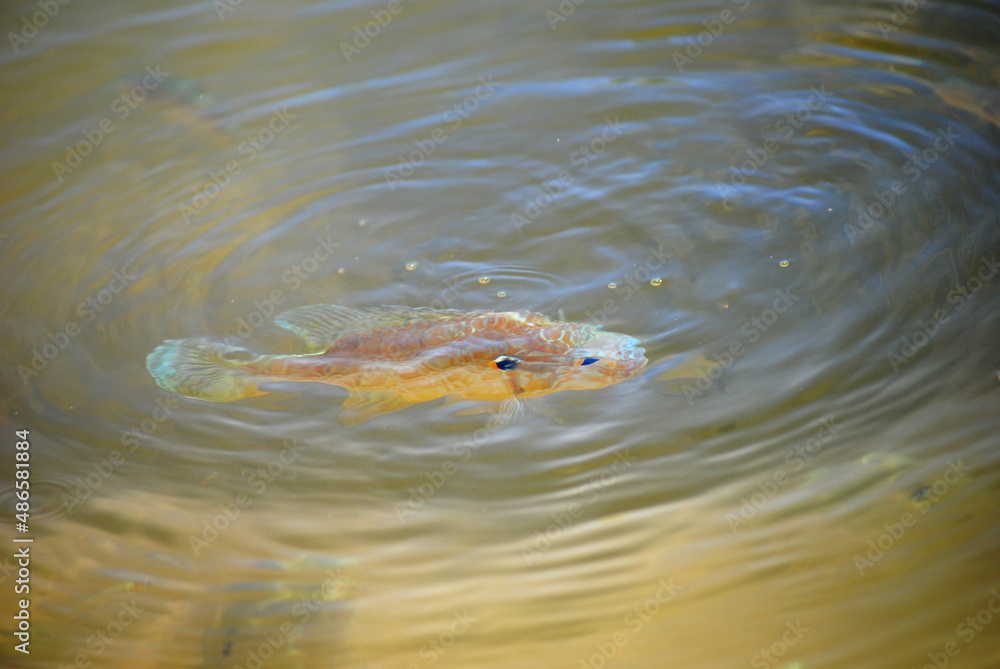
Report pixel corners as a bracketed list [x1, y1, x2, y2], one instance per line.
[274, 304, 467, 351]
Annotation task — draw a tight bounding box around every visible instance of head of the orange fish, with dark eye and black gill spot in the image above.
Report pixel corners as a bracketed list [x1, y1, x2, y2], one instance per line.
[493, 326, 648, 397]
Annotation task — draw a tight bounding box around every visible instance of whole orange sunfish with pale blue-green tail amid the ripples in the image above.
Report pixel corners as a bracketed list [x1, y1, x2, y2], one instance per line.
[146, 304, 647, 425]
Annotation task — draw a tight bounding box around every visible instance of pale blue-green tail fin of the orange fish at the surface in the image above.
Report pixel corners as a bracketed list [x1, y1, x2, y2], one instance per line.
[146, 338, 267, 402]
